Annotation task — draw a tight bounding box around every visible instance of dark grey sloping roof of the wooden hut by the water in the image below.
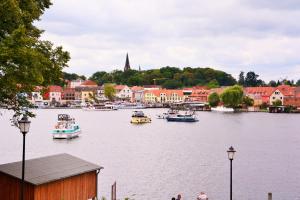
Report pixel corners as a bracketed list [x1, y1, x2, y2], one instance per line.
[0, 154, 103, 185]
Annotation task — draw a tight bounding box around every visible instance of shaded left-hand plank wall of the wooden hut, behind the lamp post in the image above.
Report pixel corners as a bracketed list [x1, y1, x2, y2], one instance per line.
[0, 172, 34, 200]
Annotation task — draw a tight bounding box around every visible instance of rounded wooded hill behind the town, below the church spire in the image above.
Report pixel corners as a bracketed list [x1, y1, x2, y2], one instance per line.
[77, 66, 236, 89]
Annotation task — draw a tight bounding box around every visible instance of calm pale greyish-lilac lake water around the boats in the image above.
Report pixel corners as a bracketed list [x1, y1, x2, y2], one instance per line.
[0, 109, 300, 200]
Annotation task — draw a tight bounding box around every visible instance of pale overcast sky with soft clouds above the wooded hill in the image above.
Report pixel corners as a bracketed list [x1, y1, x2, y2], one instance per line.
[38, 0, 300, 81]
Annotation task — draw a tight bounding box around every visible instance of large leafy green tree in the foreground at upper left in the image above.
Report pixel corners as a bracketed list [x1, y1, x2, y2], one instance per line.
[0, 0, 70, 120]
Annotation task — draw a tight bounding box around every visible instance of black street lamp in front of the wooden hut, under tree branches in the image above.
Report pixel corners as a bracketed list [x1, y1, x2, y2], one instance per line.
[18, 116, 30, 200]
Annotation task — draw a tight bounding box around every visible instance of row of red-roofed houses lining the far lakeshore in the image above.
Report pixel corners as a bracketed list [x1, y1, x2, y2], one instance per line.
[28, 79, 300, 110]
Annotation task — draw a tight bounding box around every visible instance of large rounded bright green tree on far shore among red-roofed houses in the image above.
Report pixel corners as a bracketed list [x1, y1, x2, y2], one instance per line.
[221, 85, 243, 108]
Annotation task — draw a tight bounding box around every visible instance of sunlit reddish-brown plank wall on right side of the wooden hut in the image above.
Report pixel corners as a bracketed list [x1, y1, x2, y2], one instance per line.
[34, 171, 97, 200]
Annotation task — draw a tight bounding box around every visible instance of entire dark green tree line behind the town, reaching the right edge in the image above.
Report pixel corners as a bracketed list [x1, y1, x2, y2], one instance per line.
[59, 69, 300, 89]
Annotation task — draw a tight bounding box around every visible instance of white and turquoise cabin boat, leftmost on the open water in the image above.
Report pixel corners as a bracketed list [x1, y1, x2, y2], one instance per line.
[52, 114, 81, 139]
